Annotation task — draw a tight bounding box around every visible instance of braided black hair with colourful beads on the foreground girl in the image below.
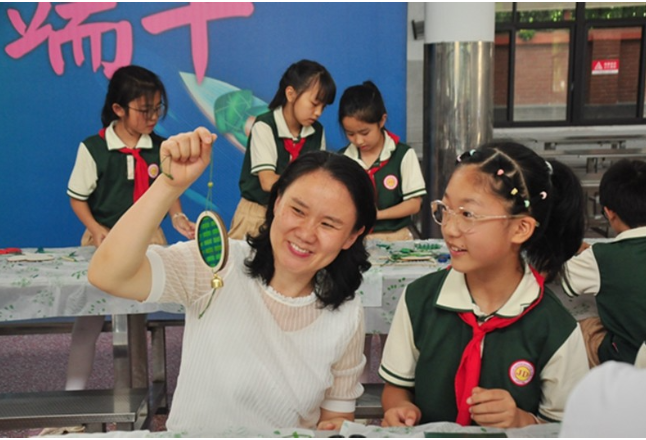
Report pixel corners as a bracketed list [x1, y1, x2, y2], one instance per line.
[458, 142, 585, 282]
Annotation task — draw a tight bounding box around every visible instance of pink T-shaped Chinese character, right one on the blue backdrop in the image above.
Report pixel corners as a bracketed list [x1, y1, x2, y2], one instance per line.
[141, 2, 254, 83]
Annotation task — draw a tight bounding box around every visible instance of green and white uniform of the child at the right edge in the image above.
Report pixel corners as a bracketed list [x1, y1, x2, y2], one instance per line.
[562, 227, 646, 364]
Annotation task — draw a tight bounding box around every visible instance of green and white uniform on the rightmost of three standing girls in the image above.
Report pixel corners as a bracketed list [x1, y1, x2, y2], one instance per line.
[340, 130, 426, 232]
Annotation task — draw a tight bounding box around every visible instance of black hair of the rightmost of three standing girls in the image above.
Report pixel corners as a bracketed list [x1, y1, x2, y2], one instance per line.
[339, 81, 387, 128]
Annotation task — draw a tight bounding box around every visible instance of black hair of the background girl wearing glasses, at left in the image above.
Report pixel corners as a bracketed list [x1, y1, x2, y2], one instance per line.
[101, 65, 168, 128]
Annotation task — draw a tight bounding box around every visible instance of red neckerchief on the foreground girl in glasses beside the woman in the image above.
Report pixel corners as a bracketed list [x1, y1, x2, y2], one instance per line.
[455, 266, 545, 426]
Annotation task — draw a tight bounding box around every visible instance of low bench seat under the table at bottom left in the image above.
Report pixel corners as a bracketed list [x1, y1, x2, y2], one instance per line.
[0, 388, 148, 432]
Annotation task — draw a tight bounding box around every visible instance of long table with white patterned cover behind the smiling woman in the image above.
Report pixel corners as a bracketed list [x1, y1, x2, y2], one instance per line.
[0, 239, 597, 388]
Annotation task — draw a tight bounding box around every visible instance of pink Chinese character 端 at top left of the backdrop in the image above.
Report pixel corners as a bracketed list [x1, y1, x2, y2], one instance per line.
[5, 2, 132, 78]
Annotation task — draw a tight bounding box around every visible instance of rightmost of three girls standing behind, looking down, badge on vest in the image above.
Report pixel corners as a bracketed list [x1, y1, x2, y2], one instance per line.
[339, 81, 426, 240]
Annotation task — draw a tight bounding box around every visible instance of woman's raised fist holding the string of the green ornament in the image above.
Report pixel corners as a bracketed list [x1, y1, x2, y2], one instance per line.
[159, 127, 217, 189]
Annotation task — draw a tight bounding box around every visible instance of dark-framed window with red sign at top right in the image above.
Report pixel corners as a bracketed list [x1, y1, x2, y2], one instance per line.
[494, 2, 646, 127]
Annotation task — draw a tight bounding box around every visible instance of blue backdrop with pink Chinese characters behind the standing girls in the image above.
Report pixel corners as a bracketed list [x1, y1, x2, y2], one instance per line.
[0, 2, 406, 248]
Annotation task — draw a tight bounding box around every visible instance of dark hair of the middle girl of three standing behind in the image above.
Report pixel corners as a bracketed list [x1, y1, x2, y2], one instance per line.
[268, 60, 336, 110]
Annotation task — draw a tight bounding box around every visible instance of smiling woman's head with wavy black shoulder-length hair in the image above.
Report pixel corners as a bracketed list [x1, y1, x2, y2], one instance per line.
[247, 151, 376, 308]
